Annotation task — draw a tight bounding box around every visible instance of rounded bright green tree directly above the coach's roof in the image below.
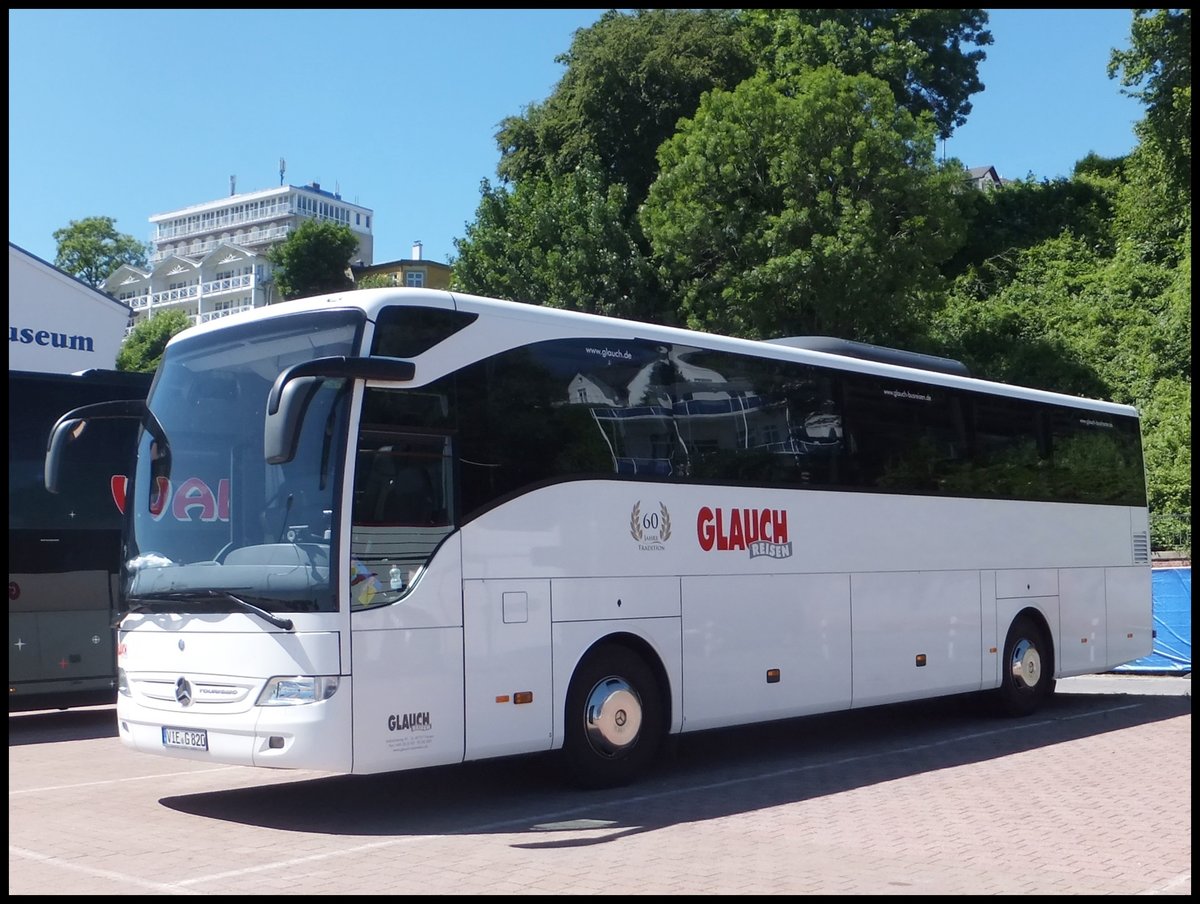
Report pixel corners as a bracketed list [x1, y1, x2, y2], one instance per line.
[642, 67, 965, 342]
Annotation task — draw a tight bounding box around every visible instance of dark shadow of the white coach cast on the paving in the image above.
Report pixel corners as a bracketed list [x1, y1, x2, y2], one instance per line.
[161, 694, 1192, 849]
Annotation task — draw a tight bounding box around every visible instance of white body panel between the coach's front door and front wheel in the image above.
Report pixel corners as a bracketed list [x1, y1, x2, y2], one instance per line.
[463, 580, 553, 760]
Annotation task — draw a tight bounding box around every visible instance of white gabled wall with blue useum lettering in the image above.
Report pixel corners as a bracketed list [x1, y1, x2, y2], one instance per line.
[8, 243, 130, 373]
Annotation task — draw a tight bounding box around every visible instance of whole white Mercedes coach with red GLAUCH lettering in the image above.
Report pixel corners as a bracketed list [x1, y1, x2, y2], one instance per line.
[47, 289, 1152, 785]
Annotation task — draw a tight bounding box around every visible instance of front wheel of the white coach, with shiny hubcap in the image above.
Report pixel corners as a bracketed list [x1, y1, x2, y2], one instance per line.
[563, 643, 665, 788]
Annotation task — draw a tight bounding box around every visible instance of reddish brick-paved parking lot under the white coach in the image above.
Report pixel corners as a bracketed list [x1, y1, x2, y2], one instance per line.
[8, 676, 1192, 894]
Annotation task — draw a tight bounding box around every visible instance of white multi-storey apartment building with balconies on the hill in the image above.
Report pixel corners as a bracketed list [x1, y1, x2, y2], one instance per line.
[101, 180, 374, 329]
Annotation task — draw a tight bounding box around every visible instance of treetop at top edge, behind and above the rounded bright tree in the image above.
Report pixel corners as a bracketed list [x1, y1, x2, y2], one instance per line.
[743, 10, 992, 138]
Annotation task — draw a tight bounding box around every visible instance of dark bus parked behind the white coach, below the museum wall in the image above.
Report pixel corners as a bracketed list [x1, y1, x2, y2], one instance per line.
[8, 370, 150, 712]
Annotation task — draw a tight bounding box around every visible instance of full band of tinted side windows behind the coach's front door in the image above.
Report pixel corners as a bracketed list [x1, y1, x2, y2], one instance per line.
[441, 339, 1144, 517]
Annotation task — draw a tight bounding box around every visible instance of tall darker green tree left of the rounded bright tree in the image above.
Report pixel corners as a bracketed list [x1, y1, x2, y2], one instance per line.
[465, 10, 752, 322]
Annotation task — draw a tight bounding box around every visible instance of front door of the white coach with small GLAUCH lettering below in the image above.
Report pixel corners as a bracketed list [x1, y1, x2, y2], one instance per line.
[346, 427, 463, 773]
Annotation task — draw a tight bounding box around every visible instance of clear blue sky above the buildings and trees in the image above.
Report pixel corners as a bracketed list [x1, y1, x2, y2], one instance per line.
[8, 10, 1144, 263]
